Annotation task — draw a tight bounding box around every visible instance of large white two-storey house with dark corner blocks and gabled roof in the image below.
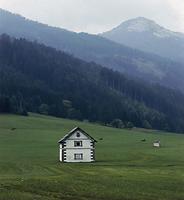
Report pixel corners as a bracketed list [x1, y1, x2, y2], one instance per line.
[59, 127, 96, 162]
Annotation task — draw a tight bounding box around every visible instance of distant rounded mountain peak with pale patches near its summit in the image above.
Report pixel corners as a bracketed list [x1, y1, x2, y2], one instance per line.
[101, 17, 184, 62]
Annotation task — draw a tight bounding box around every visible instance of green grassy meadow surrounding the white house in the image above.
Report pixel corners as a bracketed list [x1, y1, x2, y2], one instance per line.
[0, 114, 184, 200]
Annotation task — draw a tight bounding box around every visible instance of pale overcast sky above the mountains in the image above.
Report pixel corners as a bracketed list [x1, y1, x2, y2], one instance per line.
[0, 0, 184, 33]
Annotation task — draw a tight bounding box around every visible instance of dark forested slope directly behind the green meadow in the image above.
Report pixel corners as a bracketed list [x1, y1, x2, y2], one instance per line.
[0, 35, 184, 132]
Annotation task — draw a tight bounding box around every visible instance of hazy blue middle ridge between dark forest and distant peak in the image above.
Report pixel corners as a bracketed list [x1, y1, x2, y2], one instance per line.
[0, 9, 184, 91]
